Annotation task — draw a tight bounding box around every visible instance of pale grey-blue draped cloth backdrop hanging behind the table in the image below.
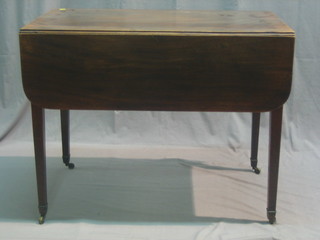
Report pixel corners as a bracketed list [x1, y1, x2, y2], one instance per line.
[0, 0, 320, 151]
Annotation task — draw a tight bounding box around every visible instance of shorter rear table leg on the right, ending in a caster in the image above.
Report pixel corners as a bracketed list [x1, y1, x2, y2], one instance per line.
[250, 113, 260, 174]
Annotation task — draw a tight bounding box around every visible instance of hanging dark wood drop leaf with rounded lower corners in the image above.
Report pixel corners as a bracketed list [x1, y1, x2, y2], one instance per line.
[20, 33, 294, 111]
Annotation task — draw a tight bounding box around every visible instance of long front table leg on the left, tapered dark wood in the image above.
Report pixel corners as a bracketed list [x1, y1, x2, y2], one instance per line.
[31, 104, 48, 224]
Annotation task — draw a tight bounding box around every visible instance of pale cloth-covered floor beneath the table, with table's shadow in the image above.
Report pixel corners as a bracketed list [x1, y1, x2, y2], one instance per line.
[0, 142, 320, 240]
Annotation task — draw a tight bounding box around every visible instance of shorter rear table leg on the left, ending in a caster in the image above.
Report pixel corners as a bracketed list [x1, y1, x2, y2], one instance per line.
[60, 110, 74, 169]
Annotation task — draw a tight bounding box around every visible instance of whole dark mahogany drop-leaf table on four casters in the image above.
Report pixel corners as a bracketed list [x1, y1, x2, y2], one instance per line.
[20, 9, 295, 223]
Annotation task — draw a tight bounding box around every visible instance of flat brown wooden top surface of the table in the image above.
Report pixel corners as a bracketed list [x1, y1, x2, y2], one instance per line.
[21, 9, 294, 36]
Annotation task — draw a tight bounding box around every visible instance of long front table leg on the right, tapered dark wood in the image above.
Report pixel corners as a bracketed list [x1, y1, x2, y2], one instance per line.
[267, 106, 283, 224]
